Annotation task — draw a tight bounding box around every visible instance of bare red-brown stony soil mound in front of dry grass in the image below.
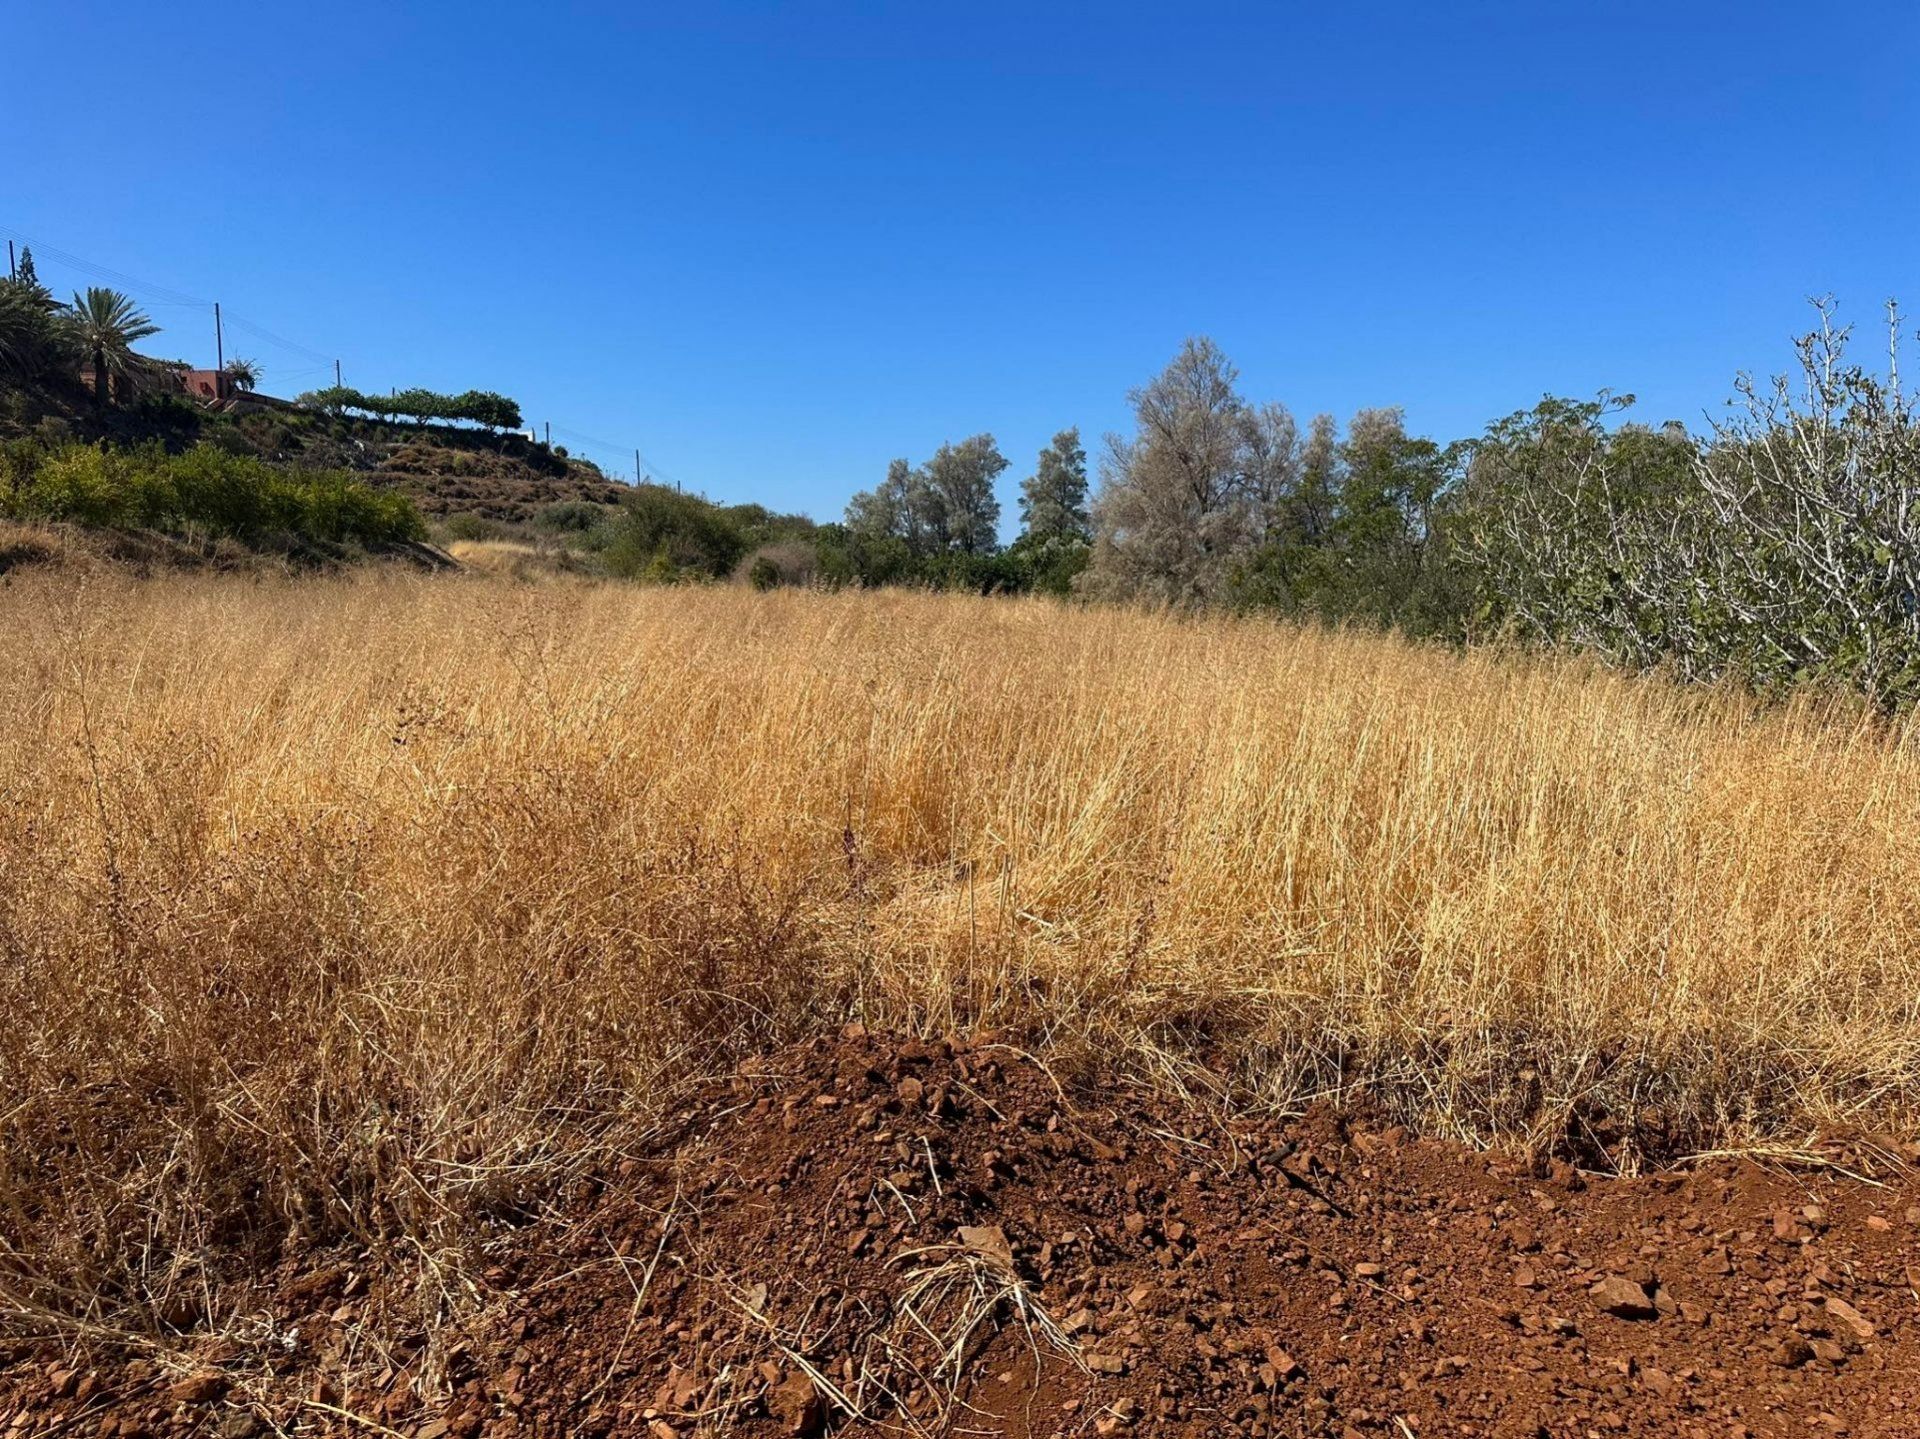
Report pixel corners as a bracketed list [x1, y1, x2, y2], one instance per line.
[0, 1032, 1920, 1439]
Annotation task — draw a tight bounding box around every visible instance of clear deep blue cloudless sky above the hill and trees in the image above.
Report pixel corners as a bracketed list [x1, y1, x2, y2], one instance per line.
[0, 0, 1920, 519]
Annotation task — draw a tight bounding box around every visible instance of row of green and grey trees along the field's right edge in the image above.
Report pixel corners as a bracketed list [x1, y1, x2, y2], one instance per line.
[818, 302, 1920, 703]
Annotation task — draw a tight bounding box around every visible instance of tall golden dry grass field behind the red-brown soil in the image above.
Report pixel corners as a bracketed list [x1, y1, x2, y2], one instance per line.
[0, 574, 1920, 1312]
